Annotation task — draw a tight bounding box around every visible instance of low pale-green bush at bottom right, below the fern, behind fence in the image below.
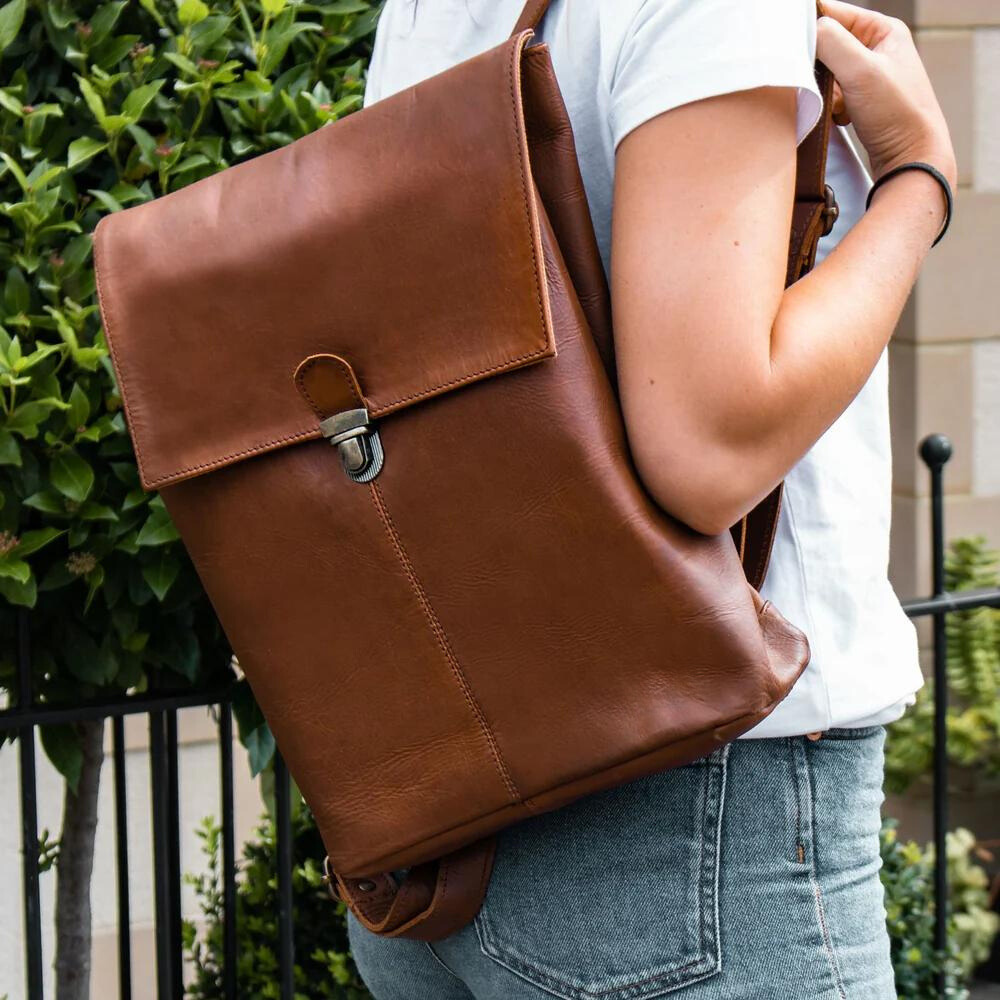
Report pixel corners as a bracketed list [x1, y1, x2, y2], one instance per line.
[881, 820, 1000, 1000]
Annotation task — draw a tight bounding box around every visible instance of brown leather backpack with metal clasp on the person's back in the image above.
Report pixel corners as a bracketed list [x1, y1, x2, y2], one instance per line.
[95, 0, 835, 939]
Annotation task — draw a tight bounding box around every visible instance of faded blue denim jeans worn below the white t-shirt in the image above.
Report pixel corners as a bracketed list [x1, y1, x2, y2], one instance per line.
[350, 727, 896, 1000]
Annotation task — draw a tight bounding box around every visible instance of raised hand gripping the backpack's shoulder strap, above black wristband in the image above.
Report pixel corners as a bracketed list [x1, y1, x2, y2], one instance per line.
[816, 0, 958, 188]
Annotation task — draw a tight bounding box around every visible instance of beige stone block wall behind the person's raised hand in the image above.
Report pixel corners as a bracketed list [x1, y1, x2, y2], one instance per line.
[869, 0, 1000, 597]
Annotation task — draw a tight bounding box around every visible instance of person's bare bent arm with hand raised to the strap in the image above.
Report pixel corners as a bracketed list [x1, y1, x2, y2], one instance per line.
[612, 2, 956, 534]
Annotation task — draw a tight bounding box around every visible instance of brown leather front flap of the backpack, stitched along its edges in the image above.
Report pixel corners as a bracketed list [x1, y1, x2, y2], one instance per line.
[95, 32, 555, 489]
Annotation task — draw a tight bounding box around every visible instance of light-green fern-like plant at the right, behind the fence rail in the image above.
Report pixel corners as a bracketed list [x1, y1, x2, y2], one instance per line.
[886, 537, 1000, 794]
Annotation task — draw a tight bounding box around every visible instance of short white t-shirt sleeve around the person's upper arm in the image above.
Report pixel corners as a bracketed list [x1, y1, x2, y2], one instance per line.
[610, 0, 823, 148]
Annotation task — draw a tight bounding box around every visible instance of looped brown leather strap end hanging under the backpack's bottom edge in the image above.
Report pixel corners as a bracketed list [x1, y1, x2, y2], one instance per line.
[329, 837, 496, 941]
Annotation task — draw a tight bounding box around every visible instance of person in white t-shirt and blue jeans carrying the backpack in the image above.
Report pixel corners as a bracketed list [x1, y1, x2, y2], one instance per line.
[349, 0, 956, 1000]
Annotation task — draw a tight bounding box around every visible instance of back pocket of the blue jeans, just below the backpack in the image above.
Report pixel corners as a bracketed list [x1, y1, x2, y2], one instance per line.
[476, 747, 728, 1000]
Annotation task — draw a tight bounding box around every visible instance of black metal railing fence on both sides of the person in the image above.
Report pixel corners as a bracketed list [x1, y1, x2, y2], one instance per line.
[0, 434, 1000, 1000]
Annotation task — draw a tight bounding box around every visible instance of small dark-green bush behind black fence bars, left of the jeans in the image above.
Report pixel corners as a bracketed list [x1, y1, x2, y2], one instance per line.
[184, 805, 371, 1000]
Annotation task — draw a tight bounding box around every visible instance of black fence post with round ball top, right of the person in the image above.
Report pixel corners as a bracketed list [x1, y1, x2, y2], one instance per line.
[920, 434, 952, 997]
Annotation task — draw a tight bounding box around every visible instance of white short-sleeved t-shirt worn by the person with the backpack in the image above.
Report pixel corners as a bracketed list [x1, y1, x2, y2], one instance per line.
[365, 0, 922, 736]
